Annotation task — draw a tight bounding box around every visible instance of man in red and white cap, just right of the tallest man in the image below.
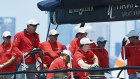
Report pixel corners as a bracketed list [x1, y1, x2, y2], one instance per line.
[38, 29, 63, 69]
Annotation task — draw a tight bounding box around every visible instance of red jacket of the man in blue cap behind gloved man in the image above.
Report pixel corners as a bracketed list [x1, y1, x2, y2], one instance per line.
[93, 48, 109, 68]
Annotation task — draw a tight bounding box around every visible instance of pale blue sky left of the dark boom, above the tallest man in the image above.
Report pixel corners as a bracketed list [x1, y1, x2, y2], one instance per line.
[0, 0, 48, 42]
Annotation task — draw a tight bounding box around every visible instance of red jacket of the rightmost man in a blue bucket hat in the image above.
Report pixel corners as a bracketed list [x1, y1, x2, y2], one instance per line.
[121, 41, 140, 74]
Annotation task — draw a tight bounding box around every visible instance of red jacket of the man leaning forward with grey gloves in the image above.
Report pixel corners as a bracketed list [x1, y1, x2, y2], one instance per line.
[73, 49, 94, 79]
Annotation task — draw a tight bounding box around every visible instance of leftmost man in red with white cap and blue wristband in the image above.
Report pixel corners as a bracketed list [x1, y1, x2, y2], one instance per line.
[0, 31, 16, 79]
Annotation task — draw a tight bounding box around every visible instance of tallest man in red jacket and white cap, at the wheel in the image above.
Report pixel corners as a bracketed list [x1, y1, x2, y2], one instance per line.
[13, 19, 40, 79]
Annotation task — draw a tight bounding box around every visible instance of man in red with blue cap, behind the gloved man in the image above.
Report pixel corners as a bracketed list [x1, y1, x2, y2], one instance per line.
[93, 37, 109, 68]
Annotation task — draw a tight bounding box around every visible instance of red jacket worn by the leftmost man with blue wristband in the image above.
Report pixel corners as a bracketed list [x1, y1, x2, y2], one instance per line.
[0, 42, 16, 72]
